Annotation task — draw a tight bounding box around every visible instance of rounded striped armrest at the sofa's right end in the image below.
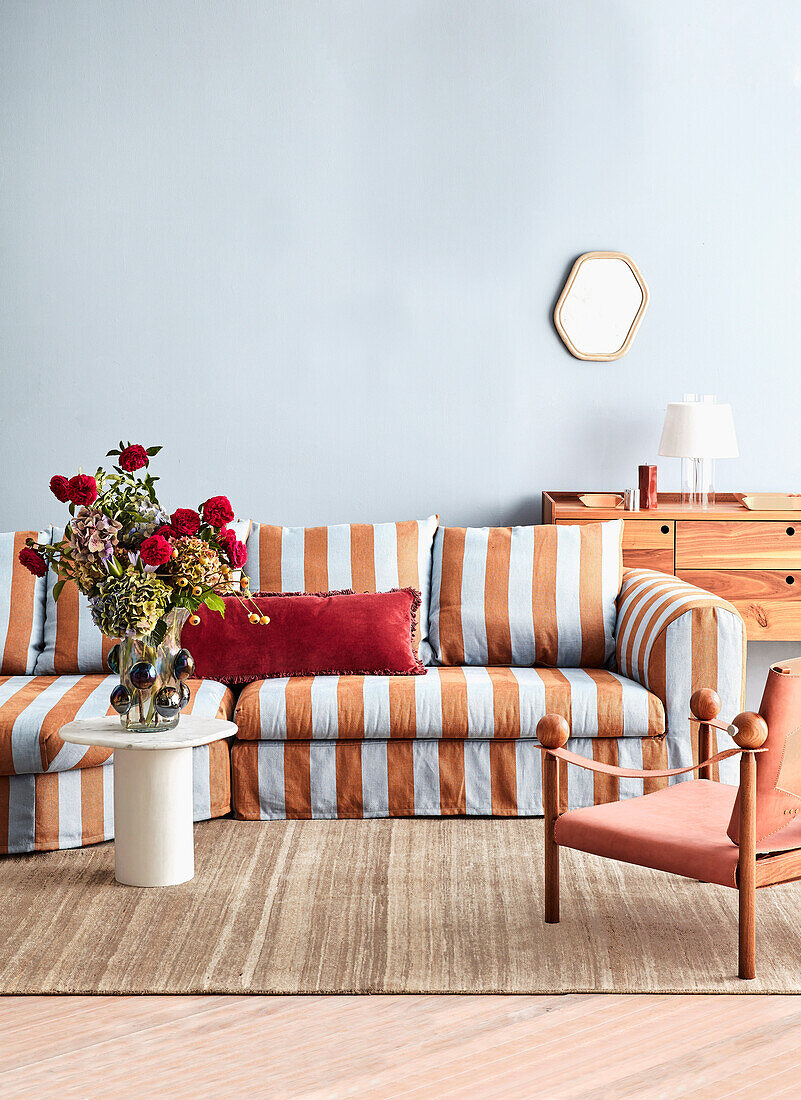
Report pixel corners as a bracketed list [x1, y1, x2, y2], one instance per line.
[615, 569, 746, 766]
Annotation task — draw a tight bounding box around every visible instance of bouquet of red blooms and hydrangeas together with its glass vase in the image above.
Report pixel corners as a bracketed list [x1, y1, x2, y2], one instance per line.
[20, 442, 270, 730]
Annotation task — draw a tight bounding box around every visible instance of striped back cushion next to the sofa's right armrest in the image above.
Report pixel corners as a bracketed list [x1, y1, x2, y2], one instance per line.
[429, 520, 623, 669]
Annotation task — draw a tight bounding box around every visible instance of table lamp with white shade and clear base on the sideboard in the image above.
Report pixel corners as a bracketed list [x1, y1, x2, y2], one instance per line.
[659, 400, 739, 508]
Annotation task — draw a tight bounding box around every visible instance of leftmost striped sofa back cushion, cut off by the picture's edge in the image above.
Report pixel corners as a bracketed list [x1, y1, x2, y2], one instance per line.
[0, 531, 53, 675]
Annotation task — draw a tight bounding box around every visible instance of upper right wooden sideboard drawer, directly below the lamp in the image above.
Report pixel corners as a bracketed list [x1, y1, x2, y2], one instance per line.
[676, 517, 801, 571]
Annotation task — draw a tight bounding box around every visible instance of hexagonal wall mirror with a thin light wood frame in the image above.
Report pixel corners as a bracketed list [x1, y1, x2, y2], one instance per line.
[553, 252, 648, 360]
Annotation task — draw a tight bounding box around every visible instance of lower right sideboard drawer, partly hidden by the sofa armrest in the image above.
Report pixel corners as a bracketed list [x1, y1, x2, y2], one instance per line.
[677, 572, 801, 641]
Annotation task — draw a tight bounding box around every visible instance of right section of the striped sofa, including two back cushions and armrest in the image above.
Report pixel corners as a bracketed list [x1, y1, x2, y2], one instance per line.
[231, 517, 745, 820]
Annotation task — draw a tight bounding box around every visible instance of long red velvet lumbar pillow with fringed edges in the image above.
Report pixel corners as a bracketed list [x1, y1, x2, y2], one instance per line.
[182, 589, 426, 684]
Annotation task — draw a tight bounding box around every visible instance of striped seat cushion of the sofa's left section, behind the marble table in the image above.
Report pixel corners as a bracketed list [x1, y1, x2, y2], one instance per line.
[0, 675, 234, 776]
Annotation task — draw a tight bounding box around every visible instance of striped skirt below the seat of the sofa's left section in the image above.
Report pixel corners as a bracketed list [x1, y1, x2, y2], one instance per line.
[0, 741, 231, 855]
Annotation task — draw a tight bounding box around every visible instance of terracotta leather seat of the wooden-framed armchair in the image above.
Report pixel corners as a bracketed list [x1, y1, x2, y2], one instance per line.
[555, 779, 739, 887]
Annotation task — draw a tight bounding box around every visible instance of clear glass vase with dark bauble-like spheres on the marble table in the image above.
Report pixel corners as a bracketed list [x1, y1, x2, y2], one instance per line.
[109, 608, 195, 733]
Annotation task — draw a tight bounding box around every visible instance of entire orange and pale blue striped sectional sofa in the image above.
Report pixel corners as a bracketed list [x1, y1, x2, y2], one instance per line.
[0, 516, 745, 853]
